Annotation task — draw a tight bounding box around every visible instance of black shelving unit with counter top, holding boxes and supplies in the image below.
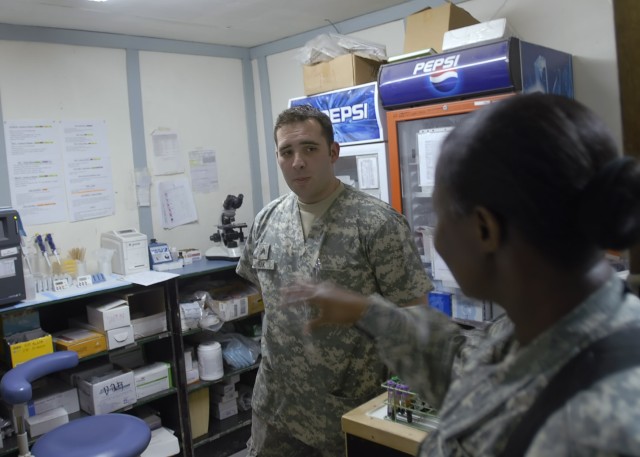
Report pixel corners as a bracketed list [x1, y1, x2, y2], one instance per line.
[0, 260, 259, 457]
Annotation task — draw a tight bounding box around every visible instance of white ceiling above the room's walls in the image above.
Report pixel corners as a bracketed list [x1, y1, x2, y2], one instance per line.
[0, 0, 407, 47]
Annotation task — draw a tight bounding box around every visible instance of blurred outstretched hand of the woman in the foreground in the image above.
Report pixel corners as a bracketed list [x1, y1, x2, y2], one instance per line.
[282, 282, 369, 331]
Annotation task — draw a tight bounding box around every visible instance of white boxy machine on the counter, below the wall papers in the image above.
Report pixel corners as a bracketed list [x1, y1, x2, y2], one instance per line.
[100, 228, 149, 275]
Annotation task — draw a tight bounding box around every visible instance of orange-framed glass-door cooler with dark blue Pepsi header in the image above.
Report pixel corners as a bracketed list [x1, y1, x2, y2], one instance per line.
[378, 38, 573, 322]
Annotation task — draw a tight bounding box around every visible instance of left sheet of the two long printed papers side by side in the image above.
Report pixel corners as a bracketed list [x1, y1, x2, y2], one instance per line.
[4, 120, 67, 225]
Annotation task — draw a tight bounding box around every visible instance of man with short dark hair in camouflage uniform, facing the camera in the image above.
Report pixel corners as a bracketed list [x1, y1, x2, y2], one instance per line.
[237, 107, 431, 457]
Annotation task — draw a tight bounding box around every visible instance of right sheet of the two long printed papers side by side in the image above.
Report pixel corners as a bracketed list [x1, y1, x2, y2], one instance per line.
[62, 120, 115, 222]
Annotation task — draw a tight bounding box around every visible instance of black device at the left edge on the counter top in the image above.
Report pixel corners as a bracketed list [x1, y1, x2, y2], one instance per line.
[0, 208, 26, 305]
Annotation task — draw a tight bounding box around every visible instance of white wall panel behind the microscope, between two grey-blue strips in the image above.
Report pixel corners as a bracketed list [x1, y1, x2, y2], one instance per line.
[140, 52, 253, 255]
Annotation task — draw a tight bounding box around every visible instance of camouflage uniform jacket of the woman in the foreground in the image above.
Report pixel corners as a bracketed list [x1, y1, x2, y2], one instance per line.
[358, 278, 640, 457]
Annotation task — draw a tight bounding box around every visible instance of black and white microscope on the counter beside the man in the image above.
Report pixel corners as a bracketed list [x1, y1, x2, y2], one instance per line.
[204, 194, 247, 261]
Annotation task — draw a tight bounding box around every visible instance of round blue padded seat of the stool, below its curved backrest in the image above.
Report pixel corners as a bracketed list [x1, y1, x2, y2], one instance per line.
[31, 413, 151, 457]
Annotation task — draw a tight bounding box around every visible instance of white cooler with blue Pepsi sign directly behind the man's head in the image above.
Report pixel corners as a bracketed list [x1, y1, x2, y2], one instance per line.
[289, 82, 389, 203]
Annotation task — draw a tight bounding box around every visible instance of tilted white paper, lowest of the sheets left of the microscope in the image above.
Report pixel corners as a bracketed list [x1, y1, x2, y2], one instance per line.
[158, 177, 198, 229]
